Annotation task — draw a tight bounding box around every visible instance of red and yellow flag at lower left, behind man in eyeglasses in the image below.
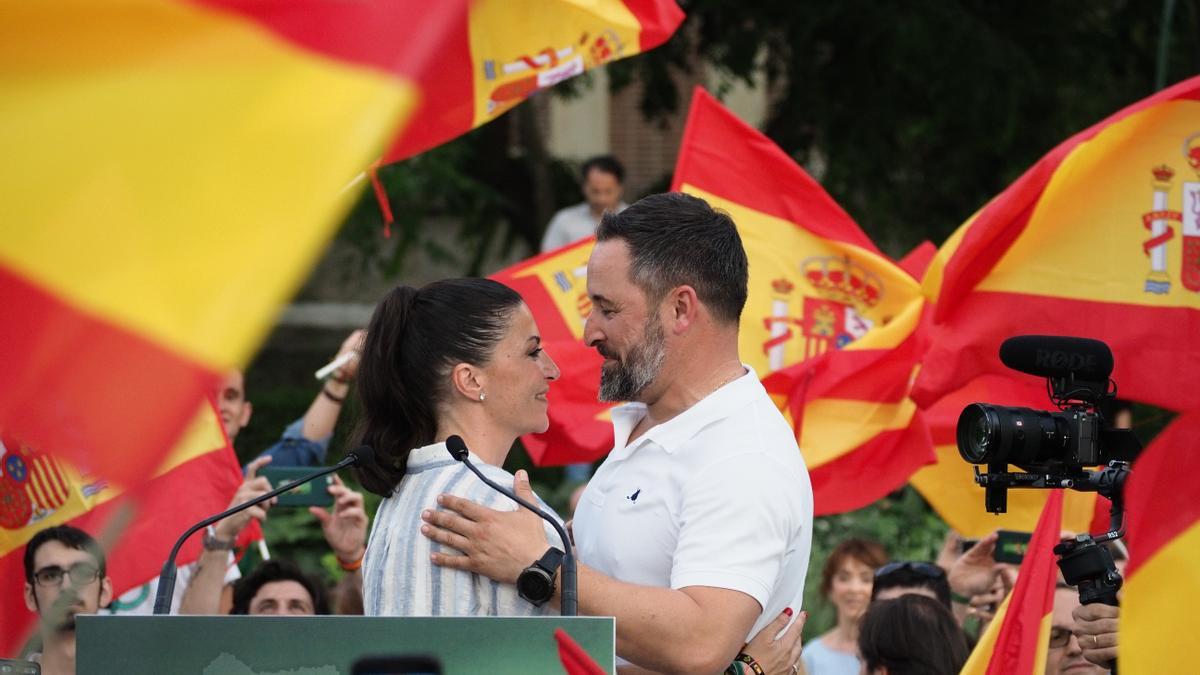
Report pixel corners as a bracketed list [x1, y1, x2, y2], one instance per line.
[0, 402, 247, 655]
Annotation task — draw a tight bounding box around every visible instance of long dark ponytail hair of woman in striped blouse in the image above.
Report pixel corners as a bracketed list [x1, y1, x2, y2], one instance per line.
[350, 279, 521, 497]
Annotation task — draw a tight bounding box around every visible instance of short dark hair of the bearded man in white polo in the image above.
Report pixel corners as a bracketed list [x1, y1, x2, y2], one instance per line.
[596, 192, 750, 324]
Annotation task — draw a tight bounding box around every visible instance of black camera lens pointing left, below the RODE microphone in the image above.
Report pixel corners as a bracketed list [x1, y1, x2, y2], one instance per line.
[955, 404, 1070, 465]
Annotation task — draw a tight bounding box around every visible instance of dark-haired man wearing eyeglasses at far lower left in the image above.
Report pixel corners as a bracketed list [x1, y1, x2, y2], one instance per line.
[25, 525, 113, 675]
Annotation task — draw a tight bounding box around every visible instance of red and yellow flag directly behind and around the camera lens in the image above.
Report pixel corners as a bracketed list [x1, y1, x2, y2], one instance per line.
[910, 375, 1108, 539]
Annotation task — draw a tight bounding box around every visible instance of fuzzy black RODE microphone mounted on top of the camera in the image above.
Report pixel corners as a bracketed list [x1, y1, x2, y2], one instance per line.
[1000, 335, 1112, 383]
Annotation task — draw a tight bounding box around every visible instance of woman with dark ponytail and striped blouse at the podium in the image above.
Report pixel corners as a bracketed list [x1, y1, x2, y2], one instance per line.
[358, 279, 563, 616]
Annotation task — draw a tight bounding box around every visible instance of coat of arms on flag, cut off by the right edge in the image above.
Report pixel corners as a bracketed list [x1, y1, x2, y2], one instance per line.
[1141, 132, 1200, 295]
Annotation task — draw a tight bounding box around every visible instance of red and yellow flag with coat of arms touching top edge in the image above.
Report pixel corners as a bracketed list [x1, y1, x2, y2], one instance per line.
[384, 0, 684, 162]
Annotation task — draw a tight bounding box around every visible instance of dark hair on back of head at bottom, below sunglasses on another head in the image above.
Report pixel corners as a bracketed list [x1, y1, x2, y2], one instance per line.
[858, 595, 970, 675]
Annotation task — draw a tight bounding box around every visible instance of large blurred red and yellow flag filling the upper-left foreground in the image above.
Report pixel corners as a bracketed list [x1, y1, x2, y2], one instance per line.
[0, 0, 464, 485]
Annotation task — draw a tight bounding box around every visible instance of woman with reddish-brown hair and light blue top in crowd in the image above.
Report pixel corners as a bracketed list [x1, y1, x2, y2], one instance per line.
[802, 539, 888, 675]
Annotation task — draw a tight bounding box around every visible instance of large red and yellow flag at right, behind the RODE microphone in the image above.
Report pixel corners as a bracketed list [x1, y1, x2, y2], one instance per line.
[913, 77, 1200, 410]
